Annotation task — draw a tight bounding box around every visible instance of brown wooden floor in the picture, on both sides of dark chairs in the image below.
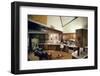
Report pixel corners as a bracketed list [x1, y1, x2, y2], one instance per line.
[28, 50, 72, 61]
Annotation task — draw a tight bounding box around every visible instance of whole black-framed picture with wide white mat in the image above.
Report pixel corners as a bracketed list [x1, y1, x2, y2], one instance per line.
[11, 2, 97, 74]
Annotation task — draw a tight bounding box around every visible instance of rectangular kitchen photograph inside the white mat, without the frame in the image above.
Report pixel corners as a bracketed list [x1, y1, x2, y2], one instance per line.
[28, 15, 88, 61]
